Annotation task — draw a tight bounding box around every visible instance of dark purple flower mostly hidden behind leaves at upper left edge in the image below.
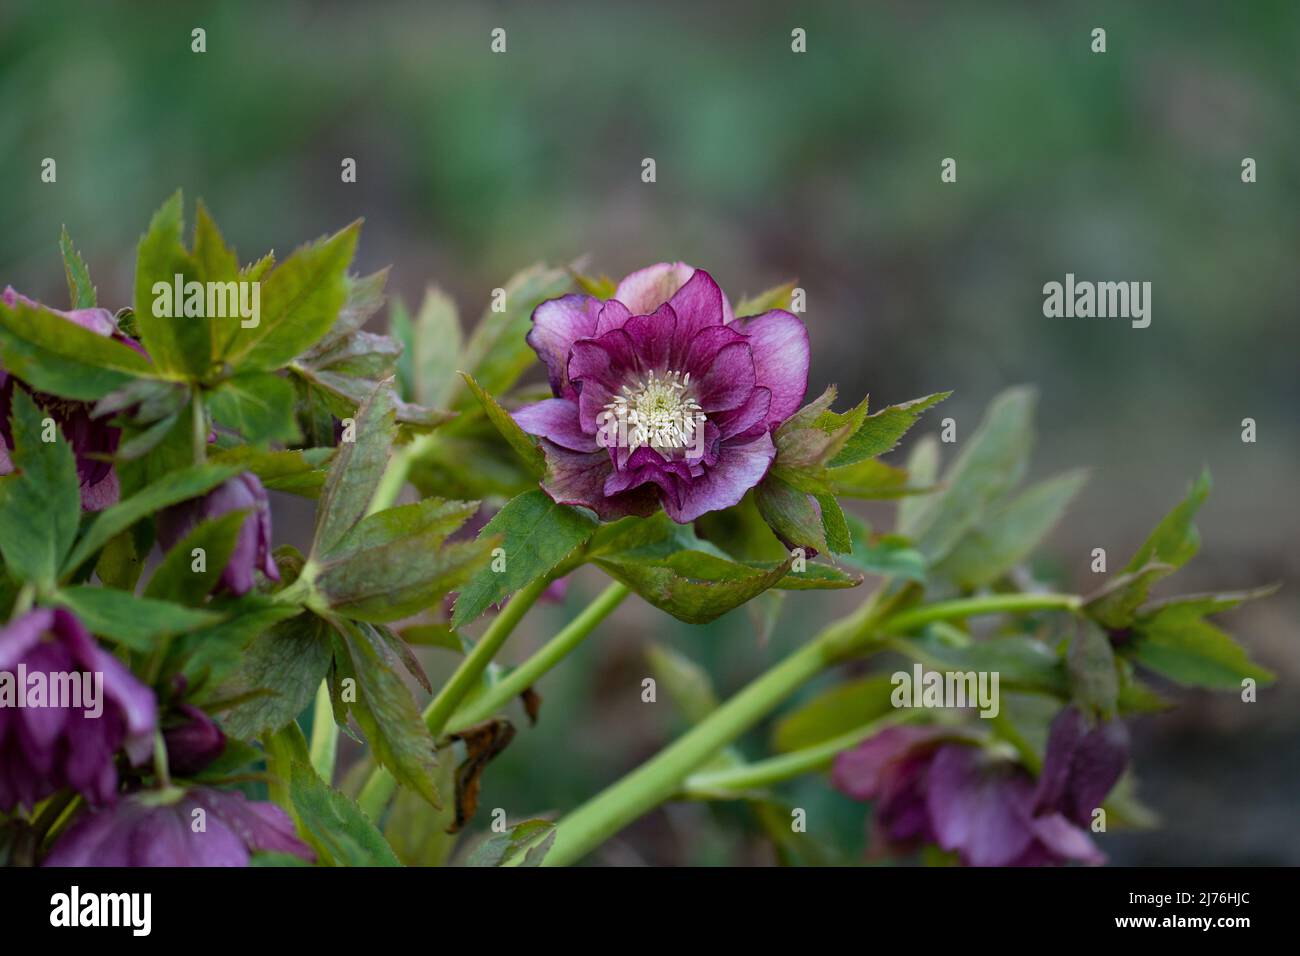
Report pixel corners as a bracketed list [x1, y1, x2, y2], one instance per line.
[0, 286, 143, 511]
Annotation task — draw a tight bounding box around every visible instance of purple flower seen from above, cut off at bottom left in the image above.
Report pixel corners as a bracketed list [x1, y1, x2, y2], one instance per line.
[42, 787, 315, 866]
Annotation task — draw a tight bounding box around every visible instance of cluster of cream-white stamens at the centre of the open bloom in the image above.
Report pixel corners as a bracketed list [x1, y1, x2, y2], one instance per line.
[601, 372, 705, 451]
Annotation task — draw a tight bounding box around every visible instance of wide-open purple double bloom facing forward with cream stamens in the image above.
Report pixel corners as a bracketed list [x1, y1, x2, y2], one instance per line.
[515, 263, 809, 523]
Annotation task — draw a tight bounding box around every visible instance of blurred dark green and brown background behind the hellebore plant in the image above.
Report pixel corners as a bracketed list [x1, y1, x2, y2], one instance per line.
[0, 0, 1300, 864]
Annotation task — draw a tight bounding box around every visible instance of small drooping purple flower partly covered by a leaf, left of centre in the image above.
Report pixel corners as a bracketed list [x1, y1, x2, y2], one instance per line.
[157, 471, 280, 594]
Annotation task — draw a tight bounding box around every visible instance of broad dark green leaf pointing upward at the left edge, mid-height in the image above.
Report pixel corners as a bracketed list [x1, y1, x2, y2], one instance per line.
[0, 388, 81, 588]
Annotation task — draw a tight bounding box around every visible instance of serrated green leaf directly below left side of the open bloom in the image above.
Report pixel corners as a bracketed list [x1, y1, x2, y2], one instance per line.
[451, 488, 599, 628]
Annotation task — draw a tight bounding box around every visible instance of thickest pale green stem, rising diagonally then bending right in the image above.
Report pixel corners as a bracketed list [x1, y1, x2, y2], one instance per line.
[533, 589, 1080, 866]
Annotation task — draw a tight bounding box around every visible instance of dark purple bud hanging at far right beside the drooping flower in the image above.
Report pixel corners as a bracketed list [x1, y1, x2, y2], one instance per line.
[1034, 705, 1128, 826]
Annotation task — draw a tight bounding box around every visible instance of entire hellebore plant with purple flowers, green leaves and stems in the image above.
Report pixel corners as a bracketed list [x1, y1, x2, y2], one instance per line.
[0, 194, 1271, 866]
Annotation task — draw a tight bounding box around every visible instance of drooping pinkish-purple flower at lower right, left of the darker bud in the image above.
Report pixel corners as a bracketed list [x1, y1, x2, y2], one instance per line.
[832, 727, 1105, 866]
